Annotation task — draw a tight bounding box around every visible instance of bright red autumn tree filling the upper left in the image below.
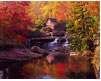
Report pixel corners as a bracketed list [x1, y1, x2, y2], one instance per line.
[0, 1, 32, 46]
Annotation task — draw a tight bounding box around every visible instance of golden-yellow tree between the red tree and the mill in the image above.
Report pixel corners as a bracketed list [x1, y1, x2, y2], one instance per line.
[26, 1, 44, 26]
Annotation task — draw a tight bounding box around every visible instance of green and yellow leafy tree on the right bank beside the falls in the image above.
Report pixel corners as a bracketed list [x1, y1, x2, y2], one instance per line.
[66, 5, 99, 52]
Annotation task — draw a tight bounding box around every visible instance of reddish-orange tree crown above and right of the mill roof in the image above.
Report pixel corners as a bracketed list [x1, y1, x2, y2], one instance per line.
[56, 1, 74, 21]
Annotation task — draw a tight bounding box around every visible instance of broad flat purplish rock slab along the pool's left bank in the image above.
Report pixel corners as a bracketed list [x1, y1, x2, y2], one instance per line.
[0, 49, 44, 63]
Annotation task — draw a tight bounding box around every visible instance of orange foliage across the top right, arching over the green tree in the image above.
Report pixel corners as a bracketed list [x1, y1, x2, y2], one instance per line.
[56, 1, 100, 21]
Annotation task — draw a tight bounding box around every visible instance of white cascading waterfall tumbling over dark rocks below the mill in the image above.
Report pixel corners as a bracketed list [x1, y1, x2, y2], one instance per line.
[43, 36, 68, 54]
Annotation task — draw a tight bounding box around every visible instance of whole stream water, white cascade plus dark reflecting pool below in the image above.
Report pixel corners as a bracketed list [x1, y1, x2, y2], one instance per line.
[0, 38, 95, 79]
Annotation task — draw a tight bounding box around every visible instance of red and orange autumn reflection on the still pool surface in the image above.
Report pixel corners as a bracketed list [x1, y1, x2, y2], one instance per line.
[7, 56, 96, 79]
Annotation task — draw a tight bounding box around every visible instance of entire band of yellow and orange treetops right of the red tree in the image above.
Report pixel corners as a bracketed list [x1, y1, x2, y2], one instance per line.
[25, 1, 100, 21]
